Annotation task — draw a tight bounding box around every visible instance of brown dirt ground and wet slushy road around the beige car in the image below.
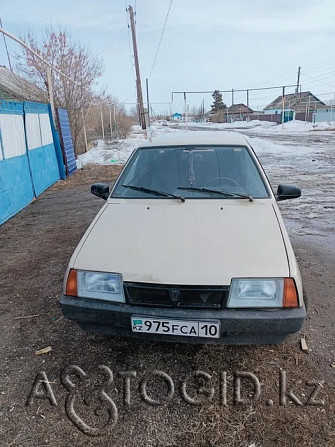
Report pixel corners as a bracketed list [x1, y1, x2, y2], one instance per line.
[0, 136, 335, 447]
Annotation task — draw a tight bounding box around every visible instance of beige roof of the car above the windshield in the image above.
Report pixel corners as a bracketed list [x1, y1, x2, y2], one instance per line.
[140, 131, 248, 148]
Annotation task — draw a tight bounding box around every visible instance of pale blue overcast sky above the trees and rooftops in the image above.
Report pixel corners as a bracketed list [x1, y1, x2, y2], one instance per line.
[0, 0, 335, 112]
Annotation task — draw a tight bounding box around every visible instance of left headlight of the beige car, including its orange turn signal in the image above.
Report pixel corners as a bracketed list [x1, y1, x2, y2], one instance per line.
[65, 270, 125, 303]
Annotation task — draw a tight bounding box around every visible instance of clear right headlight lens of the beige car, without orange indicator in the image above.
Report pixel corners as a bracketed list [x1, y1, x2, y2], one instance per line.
[227, 278, 284, 308]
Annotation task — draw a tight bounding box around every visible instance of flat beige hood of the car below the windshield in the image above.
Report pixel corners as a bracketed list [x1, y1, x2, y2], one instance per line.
[73, 199, 289, 285]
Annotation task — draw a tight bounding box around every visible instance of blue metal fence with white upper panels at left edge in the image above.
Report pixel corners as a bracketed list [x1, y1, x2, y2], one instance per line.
[0, 101, 64, 224]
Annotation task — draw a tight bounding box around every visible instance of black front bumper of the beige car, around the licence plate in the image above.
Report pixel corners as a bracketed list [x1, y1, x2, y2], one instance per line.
[60, 295, 306, 345]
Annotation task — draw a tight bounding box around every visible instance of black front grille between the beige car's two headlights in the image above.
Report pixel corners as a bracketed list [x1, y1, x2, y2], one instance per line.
[124, 283, 229, 309]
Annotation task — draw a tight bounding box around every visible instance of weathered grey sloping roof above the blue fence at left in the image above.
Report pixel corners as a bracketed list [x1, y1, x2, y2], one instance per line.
[0, 65, 48, 103]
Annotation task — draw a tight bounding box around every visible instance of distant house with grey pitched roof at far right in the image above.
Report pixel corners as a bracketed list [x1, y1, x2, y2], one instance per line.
[264, 92, 327, 115]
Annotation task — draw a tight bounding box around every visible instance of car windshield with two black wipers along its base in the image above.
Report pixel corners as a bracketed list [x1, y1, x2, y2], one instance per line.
[112, 146, 269, 199]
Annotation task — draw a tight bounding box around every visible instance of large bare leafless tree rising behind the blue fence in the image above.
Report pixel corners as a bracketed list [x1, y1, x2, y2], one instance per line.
[16, 27, 102, 154]
